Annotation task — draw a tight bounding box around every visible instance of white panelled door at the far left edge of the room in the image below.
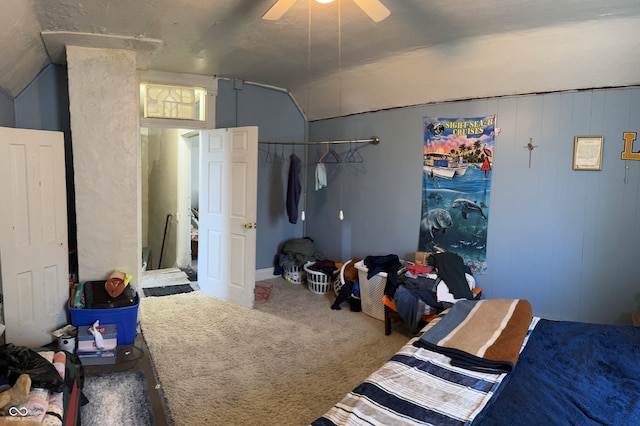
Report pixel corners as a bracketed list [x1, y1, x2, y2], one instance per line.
[0, 127, 69, 347]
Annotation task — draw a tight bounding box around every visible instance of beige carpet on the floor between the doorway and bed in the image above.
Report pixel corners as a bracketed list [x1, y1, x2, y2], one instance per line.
[140, 278, 410, 426]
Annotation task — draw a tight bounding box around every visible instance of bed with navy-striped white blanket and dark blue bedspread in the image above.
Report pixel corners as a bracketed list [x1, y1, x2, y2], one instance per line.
[312, 300, 640, 426]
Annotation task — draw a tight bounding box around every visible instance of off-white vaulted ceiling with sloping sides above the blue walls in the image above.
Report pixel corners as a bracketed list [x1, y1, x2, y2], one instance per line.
[0, 0, 640, 120]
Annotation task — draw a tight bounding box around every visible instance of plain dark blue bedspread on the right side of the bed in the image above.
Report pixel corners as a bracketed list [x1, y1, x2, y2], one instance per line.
[473, 320, 640, 426]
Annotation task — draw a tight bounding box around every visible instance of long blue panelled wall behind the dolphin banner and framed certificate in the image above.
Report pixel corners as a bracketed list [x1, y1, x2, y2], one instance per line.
[307, 87, 640, 324]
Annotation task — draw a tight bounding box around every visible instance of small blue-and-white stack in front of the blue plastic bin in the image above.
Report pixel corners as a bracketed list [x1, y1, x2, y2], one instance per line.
[76, 324, 118, 365]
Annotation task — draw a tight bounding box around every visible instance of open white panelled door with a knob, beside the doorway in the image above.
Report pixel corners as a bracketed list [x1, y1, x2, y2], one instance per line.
[198, 127, 258, 307]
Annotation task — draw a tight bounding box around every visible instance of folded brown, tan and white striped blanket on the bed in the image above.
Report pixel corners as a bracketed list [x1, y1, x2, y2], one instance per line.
[414, 299, 532, 373]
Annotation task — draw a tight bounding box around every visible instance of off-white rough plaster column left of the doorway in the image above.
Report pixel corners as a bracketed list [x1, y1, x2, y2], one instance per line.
[67, 46, 142, 289]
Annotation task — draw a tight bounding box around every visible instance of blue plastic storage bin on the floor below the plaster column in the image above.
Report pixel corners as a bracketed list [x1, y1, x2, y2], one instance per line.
[68, 292, 140, 346]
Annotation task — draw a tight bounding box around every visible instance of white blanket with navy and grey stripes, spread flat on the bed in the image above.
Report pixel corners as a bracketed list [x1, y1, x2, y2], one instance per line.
[312, 312, 538, 426]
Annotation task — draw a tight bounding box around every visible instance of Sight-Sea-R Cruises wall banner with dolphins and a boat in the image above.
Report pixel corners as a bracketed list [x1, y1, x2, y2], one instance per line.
[418, 115, 496, 273]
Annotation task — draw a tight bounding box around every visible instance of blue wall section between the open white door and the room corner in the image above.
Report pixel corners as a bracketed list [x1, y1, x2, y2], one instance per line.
[216, 80, 307, 269]
